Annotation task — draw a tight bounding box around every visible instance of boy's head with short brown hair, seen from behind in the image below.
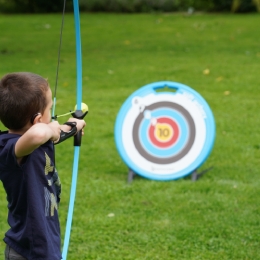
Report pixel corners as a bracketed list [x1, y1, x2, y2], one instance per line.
[0, 72, 49, 130]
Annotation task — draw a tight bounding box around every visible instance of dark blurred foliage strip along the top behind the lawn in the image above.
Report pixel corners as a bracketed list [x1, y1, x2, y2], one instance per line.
[0, 0, 260, 13]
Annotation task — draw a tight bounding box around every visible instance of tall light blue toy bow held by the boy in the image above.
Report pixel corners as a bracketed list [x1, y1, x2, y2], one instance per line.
[62, 0, 86, 260]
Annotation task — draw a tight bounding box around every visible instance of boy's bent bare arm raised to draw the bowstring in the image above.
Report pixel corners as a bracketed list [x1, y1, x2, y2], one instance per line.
[15, 121, 60, 159]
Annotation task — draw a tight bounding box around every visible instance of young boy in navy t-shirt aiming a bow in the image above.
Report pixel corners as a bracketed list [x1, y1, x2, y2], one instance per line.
[0, 72, 86, 260]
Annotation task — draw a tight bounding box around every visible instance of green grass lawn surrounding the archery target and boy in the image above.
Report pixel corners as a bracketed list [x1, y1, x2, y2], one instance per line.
[0, 13, 260, 260]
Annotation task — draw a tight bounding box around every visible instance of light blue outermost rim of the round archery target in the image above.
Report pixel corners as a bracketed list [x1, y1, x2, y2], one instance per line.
[114, 81, 216, 181]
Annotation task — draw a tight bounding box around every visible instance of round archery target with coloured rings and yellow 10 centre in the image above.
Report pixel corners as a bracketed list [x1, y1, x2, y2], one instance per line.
[115, 81, 215, 180]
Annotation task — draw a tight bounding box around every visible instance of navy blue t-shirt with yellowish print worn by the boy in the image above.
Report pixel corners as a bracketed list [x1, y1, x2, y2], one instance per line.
[0, 132, 62, 260]
